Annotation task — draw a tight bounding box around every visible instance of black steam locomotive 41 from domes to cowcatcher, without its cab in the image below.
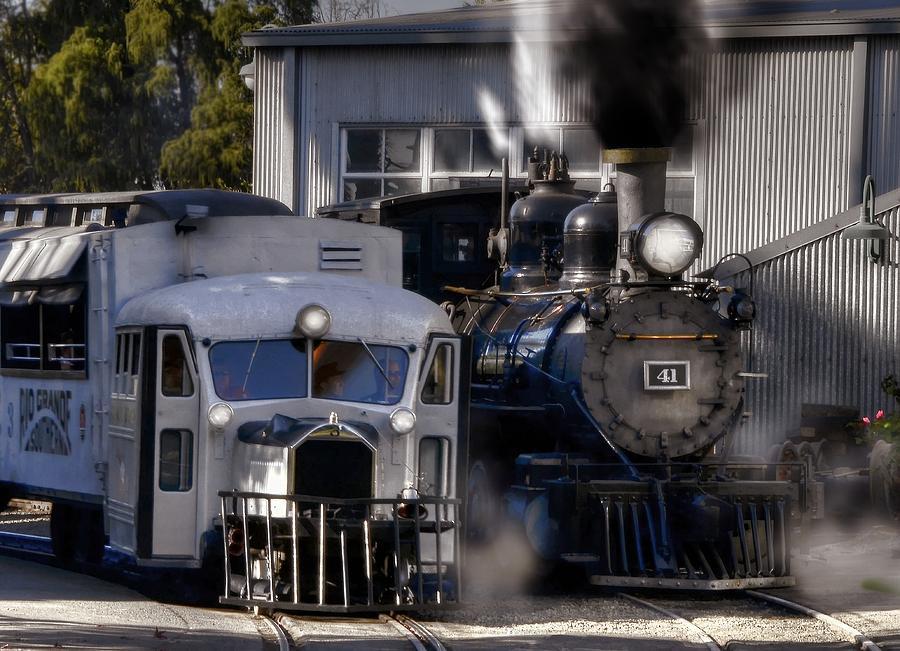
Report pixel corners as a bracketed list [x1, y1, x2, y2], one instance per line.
[456, 149, 793, 589]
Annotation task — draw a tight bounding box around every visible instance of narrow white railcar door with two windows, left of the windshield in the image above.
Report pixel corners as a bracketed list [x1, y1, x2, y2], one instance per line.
[147, 328, 200, 558]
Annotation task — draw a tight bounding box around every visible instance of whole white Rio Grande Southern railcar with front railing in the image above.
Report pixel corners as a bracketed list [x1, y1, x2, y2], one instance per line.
[0, 191, 467, 611]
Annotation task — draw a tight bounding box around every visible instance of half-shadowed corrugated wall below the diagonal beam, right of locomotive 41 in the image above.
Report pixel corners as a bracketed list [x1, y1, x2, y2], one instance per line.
[737, 211, 900, 453]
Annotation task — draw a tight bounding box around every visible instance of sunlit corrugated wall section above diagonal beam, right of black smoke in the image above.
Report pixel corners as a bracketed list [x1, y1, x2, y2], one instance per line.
[695, 38, 853, 268]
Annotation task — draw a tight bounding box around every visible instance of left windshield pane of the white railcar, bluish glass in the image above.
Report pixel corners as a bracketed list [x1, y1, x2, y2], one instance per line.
[209, 339, 307, 400]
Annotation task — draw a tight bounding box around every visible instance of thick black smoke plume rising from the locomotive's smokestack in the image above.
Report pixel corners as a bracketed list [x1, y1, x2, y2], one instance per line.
[555, 0, 703, 149]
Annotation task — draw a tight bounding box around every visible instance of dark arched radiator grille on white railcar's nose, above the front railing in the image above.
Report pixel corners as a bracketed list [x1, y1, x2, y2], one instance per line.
[294, 440, 374, 499]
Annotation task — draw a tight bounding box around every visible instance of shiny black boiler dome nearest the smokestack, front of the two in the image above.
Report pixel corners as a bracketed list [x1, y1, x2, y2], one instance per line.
[559, 191, 618, 289]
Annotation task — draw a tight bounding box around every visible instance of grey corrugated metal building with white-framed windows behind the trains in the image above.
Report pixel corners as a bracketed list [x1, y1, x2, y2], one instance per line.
[244, 0, 900, 452]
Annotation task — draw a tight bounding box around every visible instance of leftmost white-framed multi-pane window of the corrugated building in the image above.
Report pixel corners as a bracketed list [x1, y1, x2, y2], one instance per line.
[342, 129, 423, 201]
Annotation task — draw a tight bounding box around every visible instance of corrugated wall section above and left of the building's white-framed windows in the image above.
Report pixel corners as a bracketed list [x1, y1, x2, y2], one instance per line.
[301, 45, 589, 215]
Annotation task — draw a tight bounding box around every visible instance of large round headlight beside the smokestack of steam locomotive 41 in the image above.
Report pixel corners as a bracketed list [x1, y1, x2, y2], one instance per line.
[633, 213, 703, 276]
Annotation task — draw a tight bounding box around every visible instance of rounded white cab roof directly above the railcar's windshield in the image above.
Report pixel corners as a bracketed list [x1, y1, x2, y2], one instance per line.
[116, 273, 453, 343]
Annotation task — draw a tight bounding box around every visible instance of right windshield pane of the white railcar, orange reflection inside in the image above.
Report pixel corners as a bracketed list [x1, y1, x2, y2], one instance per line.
[312, 341, 409, 405]
